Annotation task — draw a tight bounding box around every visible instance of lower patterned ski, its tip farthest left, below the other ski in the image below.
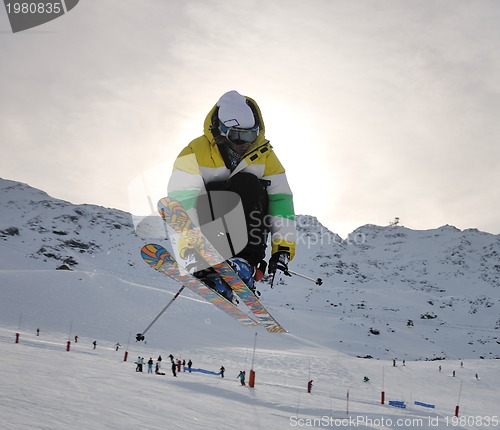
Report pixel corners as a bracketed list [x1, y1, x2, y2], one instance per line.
[141, 243, 259, 327]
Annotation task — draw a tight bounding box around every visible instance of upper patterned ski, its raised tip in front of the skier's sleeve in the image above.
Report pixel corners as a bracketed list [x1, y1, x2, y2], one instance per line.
[158, 197, 287, 333]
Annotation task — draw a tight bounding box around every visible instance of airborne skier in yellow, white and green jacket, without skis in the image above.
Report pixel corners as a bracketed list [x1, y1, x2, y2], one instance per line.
[168, 91, 296, 300]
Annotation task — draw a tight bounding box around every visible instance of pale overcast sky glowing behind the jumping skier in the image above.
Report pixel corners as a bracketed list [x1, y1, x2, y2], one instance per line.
[0, 0, 500, 237]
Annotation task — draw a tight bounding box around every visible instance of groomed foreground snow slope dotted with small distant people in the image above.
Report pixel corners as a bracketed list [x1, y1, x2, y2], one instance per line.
[0, 327, 500, 430]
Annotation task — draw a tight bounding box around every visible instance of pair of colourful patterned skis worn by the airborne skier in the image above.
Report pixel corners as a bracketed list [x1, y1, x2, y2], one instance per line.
[141, 197, 286, 334]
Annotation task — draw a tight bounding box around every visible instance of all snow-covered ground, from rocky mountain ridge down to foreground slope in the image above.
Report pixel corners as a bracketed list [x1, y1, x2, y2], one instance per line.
[0, 176, 500, 430]
